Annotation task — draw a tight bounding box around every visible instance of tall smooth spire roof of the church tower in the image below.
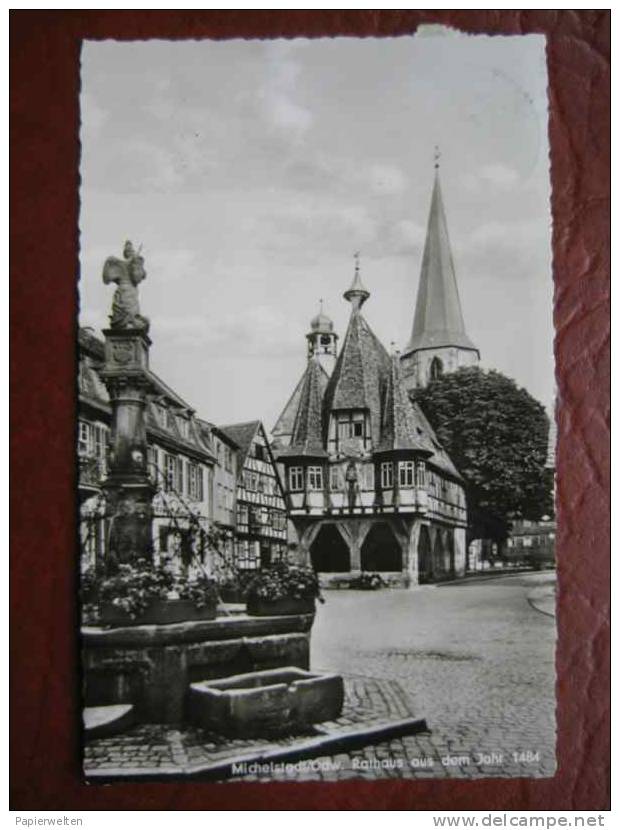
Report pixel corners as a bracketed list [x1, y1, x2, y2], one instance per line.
[405, 174, 478, 354]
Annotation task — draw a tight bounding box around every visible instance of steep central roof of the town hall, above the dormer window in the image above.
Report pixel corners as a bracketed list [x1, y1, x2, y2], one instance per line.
[323, 308, 390, 446]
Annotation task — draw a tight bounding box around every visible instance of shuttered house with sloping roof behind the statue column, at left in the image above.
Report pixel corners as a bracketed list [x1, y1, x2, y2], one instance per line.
[78, 329, 215, 569]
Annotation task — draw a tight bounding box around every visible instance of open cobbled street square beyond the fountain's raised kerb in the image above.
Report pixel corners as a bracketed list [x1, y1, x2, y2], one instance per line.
[311, 572, 556, 778]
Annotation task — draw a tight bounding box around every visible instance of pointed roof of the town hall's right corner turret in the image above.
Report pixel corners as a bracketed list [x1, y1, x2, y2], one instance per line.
[376, 355, 434, 456]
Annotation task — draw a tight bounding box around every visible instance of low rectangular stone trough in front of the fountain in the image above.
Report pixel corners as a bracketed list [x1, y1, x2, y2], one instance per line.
[188, 666, 344, 738]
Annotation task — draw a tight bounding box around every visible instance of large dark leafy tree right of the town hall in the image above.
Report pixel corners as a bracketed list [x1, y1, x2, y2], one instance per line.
[413, 367, 553, 546]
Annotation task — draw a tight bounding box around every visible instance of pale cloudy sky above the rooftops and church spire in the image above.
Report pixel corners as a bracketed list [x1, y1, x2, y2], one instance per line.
[80, 30, 554, 429]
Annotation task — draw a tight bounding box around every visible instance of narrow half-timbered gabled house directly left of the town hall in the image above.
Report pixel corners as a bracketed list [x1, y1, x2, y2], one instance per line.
[219, 421, 288, 570]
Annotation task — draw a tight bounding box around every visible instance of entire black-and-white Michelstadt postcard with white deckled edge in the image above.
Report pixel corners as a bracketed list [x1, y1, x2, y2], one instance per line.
[76, 30, 557, 784]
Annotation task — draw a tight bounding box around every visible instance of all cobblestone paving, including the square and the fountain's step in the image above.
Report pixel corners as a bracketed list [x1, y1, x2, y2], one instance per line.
[85, 573, 555, 781]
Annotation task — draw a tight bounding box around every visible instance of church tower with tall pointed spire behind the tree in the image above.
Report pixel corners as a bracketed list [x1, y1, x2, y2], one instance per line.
[401, 154, 480, 389]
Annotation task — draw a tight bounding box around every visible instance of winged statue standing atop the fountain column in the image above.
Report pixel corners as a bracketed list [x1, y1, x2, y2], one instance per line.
[103, 240, 149, 332]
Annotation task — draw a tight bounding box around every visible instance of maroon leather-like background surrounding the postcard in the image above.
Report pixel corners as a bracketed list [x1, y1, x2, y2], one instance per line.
[10, 10, 610, 810]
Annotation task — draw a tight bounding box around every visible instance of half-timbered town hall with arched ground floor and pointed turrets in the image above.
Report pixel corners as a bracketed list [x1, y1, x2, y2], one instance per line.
[273, 263, 466, 585]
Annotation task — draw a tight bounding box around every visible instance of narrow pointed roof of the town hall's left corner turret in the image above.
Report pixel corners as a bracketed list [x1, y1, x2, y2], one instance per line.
[278, 357, 327, 458]
